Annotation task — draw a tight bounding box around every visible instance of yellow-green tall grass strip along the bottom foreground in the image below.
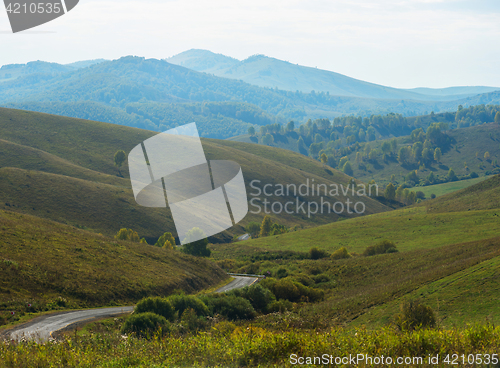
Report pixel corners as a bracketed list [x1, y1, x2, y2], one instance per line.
[0, 322, 500, 367]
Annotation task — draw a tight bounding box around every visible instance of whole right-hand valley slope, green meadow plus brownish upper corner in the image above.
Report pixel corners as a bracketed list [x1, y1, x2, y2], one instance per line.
[220, 175, 500, 252]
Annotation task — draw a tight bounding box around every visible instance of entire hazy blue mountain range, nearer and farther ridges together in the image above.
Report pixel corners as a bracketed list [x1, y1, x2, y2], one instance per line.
[0, 50, 500, 139]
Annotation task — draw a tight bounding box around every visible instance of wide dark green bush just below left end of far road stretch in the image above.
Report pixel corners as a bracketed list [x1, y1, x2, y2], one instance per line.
[204, 294, 256, 321]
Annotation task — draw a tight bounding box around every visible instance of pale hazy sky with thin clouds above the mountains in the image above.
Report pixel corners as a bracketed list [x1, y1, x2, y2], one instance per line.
[0, 0, 500, 88]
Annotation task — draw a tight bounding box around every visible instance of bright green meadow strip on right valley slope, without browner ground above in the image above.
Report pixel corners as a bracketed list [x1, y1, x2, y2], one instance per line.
[219, 208, 500, 255]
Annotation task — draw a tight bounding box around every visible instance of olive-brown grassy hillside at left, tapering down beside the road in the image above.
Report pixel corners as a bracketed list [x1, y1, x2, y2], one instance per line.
[0, 210, 226, 324]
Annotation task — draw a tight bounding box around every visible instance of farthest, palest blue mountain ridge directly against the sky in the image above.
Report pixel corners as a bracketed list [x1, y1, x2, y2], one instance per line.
[165, 49, 500, 101]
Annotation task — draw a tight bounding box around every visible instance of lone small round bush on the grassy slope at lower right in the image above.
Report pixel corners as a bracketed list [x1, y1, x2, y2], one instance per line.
[396, 301, 436, 331]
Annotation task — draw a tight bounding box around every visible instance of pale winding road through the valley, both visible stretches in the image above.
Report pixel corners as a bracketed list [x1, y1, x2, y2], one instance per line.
[2, 276, 259, 342]
